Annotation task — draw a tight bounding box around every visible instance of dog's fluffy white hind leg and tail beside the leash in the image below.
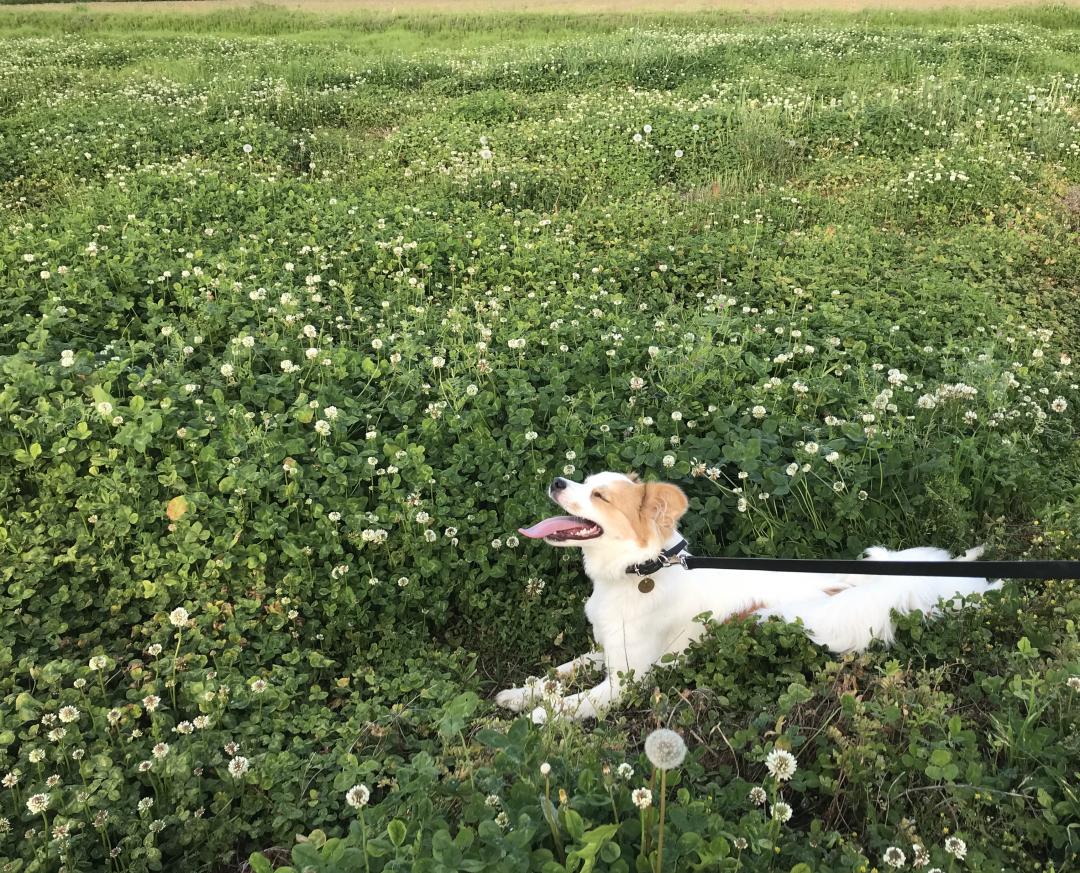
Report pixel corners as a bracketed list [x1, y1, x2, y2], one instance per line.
[764, 546, 1001, 652]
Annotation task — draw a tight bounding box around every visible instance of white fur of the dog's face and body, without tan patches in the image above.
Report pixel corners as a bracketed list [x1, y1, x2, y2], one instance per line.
[496, 473, 1000, 722]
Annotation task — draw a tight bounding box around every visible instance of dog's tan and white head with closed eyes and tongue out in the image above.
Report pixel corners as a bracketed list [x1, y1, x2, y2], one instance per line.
[521, 473, 688, 563]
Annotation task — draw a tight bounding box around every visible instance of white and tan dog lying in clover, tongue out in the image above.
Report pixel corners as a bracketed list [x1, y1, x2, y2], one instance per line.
[495, 472, 1000, 723]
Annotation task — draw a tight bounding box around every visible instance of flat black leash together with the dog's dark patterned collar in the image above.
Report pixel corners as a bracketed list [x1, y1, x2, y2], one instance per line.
[626, 539, 1080, 579]
